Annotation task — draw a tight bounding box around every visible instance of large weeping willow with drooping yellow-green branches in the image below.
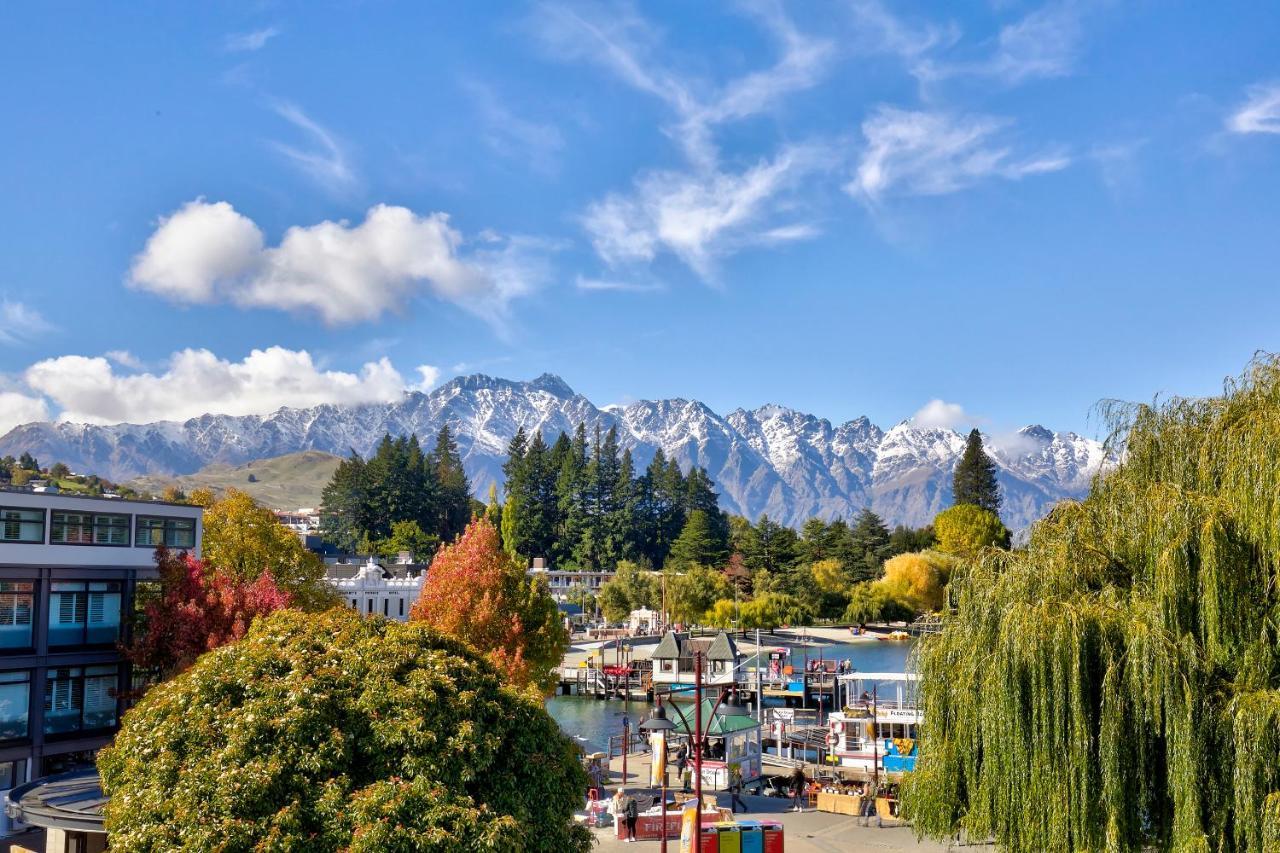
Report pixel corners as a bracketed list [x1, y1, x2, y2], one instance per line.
[904, 357, 1280, 853]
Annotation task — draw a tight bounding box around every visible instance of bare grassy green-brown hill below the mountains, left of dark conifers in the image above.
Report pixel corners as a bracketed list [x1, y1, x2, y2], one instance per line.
[128, 451, 342, 510]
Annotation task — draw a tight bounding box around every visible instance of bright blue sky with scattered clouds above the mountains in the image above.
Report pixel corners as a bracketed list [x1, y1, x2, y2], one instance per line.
[0, 0, 1280, 434]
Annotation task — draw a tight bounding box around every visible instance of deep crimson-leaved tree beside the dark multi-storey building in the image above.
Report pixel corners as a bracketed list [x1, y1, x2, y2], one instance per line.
[127, 547, 291, 678]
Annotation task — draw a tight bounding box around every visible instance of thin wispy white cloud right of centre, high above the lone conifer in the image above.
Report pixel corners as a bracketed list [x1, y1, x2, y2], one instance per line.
[845, 106, 1070, 201]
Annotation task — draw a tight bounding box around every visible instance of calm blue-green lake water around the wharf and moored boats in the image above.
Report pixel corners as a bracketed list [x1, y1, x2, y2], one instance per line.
[547, 630, 914, 752]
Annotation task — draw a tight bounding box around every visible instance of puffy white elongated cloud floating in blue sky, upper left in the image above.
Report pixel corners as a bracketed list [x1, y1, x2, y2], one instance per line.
[129, 199, 545, 325]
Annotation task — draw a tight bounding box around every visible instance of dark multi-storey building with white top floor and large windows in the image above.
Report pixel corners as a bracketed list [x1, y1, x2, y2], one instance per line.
[0, 491, 202, 829]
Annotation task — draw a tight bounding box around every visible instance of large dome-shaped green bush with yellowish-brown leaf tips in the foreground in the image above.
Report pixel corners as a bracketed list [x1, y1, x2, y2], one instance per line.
[99, 610, 589, 852]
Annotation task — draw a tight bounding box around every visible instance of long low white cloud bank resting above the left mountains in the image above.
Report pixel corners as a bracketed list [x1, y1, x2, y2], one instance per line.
[23, 347, 406, 424]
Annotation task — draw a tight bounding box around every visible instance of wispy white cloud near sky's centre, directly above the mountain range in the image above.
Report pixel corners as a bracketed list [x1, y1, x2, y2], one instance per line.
[582, 147, 818, 279]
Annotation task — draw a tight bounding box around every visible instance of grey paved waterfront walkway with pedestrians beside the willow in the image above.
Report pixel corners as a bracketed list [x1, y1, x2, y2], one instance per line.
[594, 794, 989, 853]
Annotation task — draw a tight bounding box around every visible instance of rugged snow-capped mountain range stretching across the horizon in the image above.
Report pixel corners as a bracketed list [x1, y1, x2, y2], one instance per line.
[0, 374, 1108, 529]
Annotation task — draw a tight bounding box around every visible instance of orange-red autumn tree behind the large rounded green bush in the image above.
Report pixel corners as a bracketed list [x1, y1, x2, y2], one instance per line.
[410, 517, 568, 694]
